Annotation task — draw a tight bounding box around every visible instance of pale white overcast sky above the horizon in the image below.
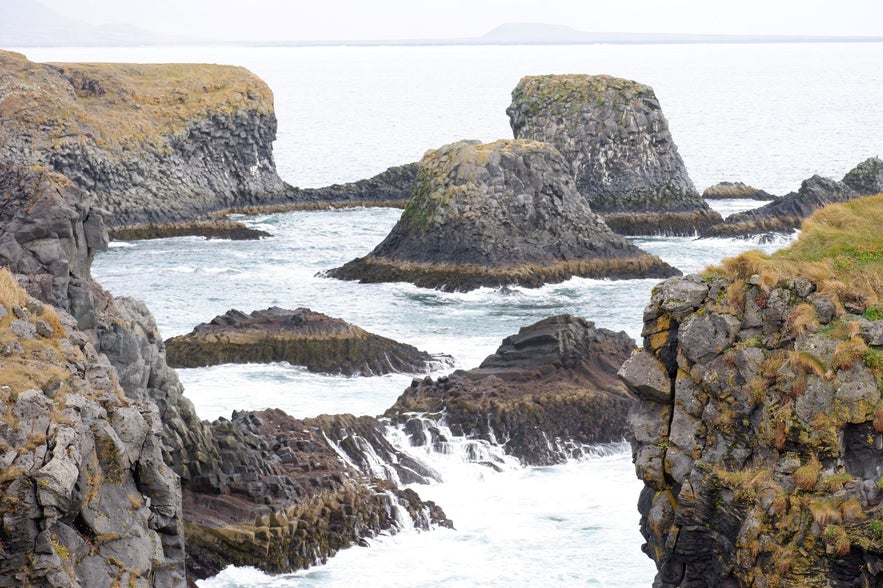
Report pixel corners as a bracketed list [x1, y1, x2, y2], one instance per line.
[32, 0, 883, 41]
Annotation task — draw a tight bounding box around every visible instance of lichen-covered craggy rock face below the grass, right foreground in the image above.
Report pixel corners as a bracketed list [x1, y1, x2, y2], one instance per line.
[620, 276, 883, 588]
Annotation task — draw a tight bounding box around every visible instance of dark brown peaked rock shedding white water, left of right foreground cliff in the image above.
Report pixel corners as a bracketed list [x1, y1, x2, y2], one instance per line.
[385, 315, 635, 465]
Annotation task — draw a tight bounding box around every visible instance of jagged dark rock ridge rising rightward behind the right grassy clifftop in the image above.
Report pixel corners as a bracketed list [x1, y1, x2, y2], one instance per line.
[702, 157, 883, 237]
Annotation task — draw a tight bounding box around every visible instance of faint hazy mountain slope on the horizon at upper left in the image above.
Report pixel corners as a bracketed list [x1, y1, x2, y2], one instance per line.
[0, 0, 193, 48]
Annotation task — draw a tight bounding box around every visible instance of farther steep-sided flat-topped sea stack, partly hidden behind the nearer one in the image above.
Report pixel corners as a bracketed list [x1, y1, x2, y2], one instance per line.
[506, 75, 720, 235]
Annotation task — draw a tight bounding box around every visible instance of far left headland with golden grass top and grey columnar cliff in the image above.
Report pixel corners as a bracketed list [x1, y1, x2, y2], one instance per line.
[0, 52, 290, 226]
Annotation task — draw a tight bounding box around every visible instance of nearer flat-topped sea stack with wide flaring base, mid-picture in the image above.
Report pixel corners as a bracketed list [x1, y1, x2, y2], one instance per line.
[328, 139, 678, 291]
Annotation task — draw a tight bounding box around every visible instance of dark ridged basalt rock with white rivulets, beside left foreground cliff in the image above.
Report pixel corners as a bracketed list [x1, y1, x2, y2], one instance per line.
[184, 410, 451, 578]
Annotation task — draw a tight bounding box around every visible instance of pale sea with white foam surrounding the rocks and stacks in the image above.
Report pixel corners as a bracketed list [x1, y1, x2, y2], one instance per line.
[12, 43, 883, 588]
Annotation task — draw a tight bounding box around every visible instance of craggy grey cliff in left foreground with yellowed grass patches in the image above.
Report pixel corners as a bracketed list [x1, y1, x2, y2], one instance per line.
[0, 165, 185, 587]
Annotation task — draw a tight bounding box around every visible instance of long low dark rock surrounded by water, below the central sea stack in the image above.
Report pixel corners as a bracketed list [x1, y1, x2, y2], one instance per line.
[166, 307, 444, 376]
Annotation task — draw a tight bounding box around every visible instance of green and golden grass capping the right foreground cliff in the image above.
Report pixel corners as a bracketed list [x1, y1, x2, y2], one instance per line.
[706, 194, 883, 312]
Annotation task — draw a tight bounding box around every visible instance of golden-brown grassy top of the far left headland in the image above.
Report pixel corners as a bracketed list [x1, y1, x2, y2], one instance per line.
[0, 51, 273, 151]
